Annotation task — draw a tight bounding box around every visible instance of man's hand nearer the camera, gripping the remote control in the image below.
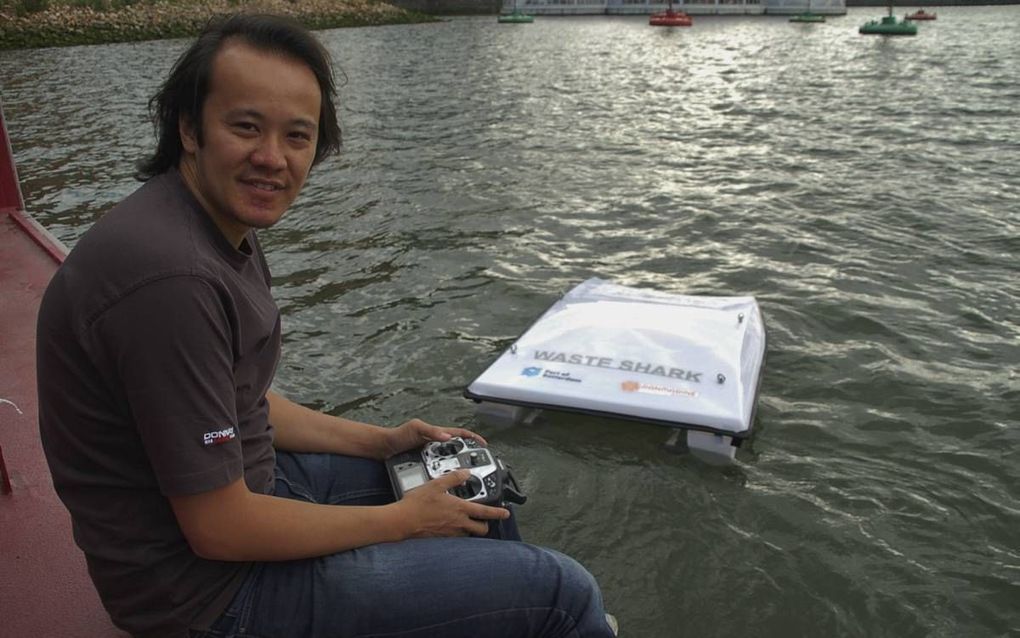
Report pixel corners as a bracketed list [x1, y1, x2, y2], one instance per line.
[397, 467, 510, 538]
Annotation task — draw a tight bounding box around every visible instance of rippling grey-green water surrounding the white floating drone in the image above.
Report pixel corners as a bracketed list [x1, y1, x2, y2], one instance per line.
[0, 6, 1020, 638]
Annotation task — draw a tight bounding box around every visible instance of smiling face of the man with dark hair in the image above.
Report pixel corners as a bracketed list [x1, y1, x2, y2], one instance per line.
[180, 41, 321, 246]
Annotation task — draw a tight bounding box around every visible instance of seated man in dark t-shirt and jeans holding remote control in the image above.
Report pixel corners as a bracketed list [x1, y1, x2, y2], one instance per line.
[38, 15, 613, 638]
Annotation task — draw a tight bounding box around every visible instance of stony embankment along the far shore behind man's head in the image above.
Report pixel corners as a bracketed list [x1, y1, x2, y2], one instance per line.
[0, 0, 436, 49]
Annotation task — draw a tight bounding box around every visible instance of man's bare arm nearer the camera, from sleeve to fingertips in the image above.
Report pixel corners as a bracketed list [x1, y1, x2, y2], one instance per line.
[169, 470, 510, 560]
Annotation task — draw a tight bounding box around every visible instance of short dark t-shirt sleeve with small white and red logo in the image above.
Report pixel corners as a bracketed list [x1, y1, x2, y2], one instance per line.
[86, 276, 244, 496]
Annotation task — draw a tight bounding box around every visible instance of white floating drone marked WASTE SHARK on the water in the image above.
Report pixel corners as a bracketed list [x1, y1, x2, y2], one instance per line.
[464, 279, 766, 463]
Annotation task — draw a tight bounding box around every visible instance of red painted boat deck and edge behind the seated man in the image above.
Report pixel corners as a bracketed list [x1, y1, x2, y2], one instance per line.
[0, 105, 128, 638]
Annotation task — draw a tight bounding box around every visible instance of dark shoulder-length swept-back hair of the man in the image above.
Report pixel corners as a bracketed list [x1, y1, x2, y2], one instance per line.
[136, 13, 341, 182]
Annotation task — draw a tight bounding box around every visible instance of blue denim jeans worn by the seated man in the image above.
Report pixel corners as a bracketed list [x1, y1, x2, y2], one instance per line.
[193, 452, 613, 638]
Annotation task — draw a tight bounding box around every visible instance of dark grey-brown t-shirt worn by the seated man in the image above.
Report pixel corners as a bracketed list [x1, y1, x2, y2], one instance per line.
[38, 170, 281, 638]
